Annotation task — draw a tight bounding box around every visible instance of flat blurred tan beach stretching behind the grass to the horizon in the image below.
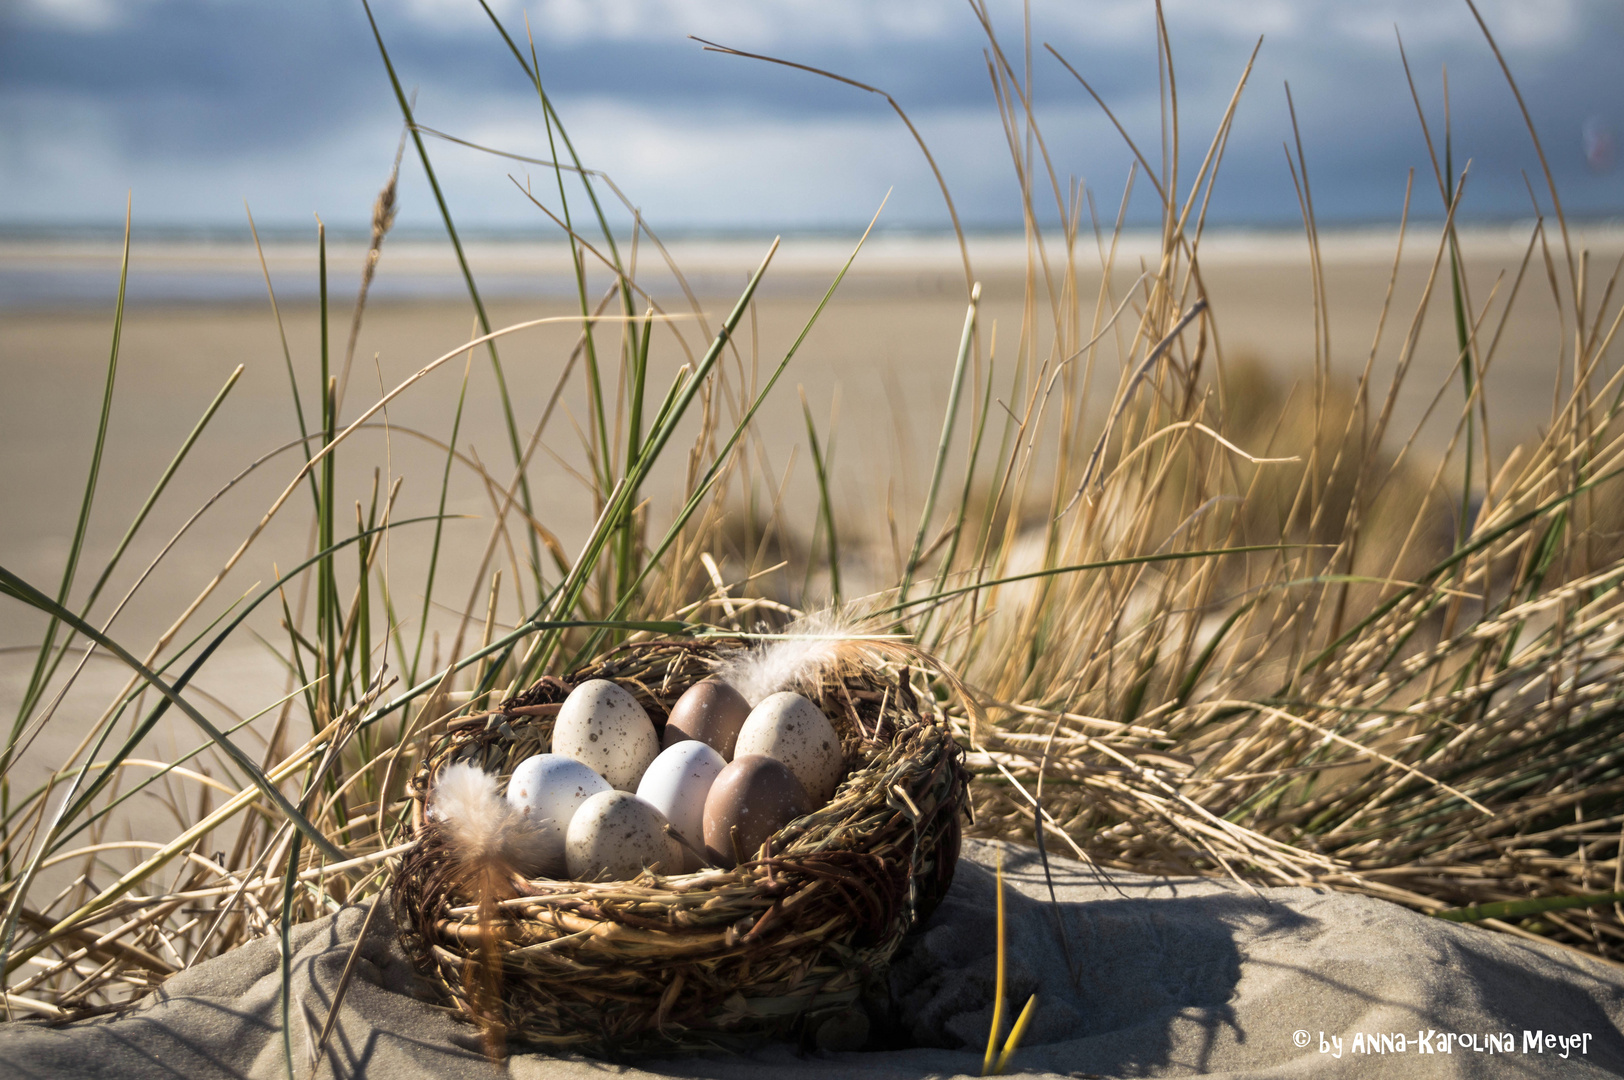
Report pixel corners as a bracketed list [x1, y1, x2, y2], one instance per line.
[0, 226, 1624, 825]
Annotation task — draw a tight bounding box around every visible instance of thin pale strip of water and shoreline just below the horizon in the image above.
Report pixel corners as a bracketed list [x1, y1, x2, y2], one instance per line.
[0, 221, 1624, 310]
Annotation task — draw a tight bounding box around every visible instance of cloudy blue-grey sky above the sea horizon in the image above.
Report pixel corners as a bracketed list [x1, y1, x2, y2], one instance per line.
[0, 0, 1624, 232]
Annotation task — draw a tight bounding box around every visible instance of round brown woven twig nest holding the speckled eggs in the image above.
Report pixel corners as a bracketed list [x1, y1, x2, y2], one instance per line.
[395, 638, 968, 1057]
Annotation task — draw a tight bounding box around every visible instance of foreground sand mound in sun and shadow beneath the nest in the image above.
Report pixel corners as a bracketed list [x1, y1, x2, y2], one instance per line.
[0, 843, 1624, 1080]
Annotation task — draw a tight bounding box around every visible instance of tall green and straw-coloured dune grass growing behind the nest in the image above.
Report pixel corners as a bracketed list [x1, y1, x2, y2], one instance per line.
[0, 0, 1624, 1032]
